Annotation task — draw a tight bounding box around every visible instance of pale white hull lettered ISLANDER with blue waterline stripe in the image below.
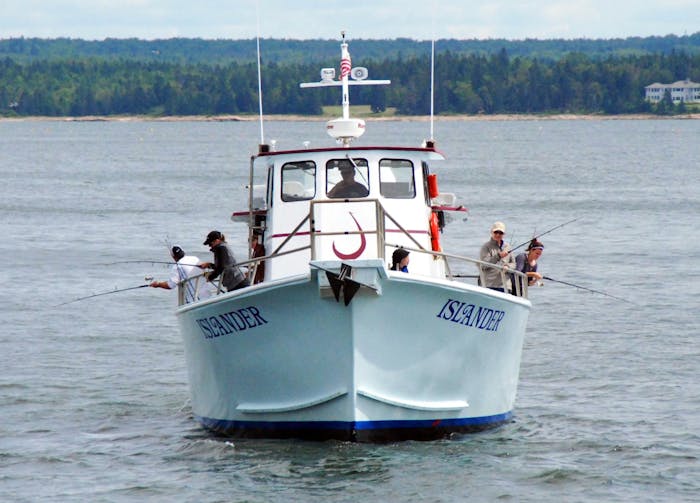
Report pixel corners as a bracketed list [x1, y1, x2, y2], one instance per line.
[178, 260, 530, 442]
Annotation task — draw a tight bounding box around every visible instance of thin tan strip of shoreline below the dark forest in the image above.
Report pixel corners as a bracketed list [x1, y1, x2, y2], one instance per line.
[0, 113, 700, 122]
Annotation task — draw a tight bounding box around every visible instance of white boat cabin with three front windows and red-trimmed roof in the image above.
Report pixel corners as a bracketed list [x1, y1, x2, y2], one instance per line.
[238, 147, 444, 281]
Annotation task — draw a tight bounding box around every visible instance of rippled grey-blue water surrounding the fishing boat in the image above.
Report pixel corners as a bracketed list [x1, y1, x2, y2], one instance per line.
[0, 120, 700, 502]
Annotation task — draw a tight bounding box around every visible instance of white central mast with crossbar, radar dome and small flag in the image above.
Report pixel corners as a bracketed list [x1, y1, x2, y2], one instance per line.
[299, 31, 391, 147]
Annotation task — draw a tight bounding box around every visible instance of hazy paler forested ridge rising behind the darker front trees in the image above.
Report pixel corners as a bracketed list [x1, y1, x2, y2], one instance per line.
[0, 32, 700, 65]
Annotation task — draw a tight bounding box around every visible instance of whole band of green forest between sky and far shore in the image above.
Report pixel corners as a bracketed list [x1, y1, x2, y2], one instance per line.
[0, 33, 700, 116]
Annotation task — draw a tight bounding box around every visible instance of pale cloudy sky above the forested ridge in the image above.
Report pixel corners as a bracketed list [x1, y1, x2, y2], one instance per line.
[0, 0, 700, 40]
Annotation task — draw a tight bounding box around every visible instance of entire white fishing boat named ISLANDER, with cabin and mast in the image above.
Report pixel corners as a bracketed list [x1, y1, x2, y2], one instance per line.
[177, 33, 531, 442]
